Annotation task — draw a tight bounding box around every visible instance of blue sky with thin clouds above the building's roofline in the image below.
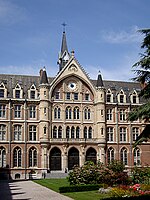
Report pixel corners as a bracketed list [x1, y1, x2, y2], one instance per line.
[0, 0, 150, 81]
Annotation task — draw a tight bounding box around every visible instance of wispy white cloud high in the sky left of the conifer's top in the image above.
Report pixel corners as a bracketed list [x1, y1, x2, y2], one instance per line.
[101, 26, 142, 44]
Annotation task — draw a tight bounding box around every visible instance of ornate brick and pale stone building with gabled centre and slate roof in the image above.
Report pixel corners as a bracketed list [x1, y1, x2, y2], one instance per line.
[0, 32, 150, 179]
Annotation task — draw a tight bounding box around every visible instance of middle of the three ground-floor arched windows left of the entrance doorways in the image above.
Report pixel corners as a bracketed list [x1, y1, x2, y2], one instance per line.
[13, 147, 22, 167]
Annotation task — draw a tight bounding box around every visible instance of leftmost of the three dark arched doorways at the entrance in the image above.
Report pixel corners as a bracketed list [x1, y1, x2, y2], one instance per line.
[49, 147, 61, 171]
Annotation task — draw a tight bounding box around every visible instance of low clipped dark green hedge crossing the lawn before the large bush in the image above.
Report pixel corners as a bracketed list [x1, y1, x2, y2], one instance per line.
[59, 184, 100, 193]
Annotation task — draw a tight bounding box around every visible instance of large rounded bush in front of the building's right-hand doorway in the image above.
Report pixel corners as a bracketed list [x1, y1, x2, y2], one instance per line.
[68, 161, 128, 186]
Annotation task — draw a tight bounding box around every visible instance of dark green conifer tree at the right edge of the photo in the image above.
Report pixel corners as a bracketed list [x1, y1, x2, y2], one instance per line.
[128, 29, 150, 146]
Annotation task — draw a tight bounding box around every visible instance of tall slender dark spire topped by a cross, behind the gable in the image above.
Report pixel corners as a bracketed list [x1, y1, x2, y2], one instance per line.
[57, 23, 70, 70]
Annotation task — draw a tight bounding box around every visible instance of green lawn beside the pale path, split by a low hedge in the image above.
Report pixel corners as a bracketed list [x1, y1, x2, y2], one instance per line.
[34, 179, 110, 200]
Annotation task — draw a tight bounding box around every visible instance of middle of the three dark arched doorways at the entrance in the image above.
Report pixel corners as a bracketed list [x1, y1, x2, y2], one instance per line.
[68, 147, 79, 170]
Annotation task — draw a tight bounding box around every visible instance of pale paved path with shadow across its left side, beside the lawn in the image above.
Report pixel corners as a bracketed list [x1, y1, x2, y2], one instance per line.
[0, 181, 71, 200]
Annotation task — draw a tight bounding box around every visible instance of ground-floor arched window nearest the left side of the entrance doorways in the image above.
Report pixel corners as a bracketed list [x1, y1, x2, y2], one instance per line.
[29, 147, 37, 167]
